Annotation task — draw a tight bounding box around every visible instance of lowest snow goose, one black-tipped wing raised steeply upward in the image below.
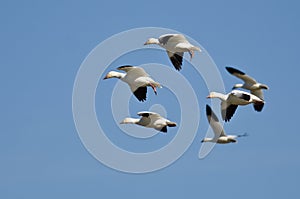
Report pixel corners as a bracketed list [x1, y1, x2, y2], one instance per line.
[202, 105, 247, 144]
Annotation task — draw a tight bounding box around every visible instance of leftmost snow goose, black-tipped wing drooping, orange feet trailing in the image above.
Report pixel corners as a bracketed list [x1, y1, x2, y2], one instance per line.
[104, 65, 161, 102]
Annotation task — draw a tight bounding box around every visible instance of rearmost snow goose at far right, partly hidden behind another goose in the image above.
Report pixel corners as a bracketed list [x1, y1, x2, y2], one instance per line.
[226, 67, 269, 111]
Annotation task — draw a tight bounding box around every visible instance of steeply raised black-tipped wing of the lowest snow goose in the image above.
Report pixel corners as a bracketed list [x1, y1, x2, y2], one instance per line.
[206, 105, 226, 138]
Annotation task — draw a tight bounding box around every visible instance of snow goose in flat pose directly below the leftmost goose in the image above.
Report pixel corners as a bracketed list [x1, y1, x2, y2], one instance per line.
[121, 111, 177, 133]
